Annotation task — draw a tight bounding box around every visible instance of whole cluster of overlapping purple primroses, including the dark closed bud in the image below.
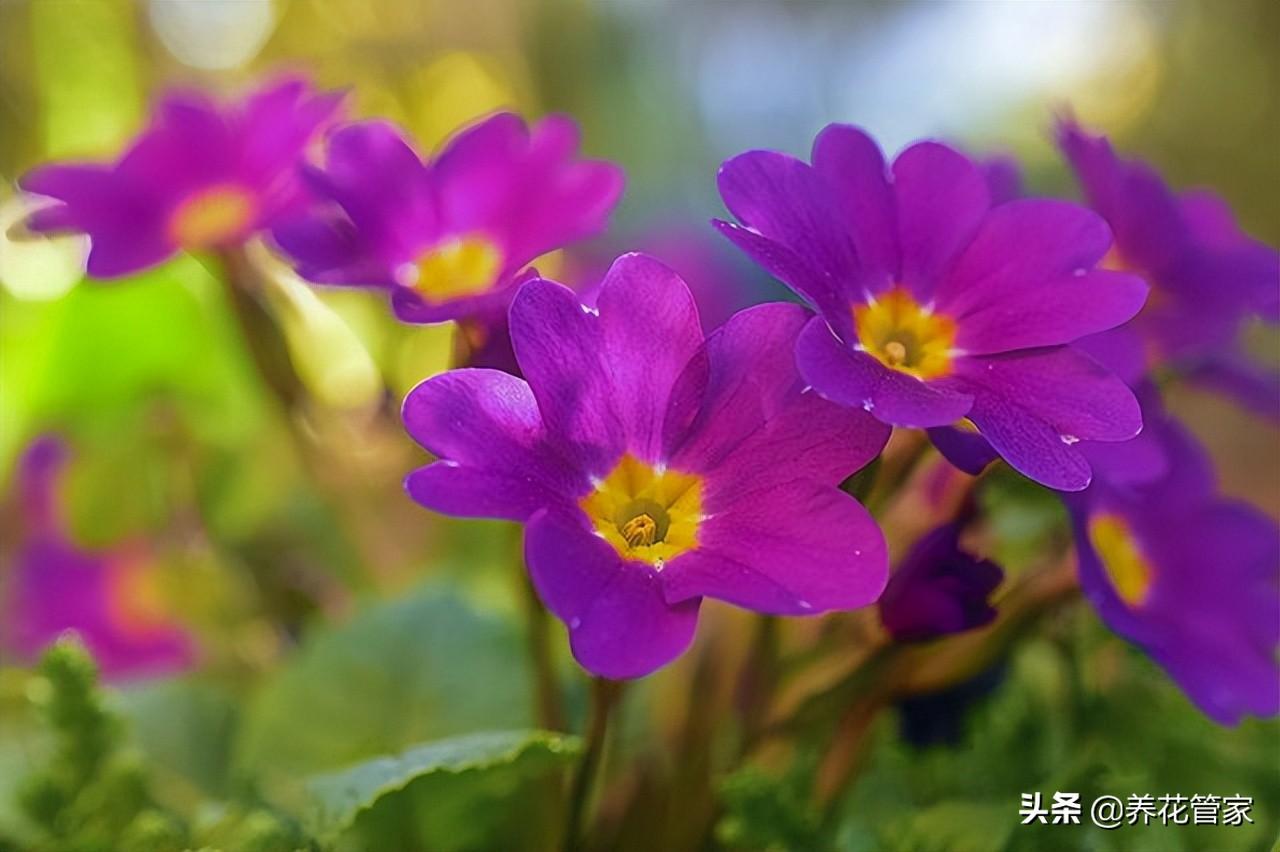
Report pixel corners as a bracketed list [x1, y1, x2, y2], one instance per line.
[12, 81, 1280, 722]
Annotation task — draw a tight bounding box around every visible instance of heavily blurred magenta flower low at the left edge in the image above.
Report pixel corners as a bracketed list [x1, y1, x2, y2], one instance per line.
[0, 436, 196, 679]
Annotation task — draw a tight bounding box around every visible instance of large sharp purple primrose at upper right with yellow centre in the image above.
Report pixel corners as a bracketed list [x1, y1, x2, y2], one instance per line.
[717, 125, 1147, 490]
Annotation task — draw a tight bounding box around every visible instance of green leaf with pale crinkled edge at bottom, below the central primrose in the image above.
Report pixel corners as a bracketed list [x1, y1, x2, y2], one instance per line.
[306, 730, 580, 851]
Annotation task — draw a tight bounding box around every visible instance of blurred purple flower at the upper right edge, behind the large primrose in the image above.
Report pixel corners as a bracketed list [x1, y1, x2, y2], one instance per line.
[1057, 119, 1280, 418]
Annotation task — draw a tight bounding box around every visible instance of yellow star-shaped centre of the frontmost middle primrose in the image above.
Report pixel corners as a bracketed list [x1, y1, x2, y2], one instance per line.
[579, 455, 703, 569]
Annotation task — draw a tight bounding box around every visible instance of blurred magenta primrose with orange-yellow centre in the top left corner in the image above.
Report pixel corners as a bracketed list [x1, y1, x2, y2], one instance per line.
[19, 79, 340, 278]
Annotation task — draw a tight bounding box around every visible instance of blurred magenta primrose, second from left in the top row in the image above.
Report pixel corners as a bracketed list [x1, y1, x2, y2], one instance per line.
[274, 113, 623, 322]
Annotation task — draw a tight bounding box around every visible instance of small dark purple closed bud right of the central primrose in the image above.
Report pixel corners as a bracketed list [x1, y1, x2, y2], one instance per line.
[879, 522, 1004, 642]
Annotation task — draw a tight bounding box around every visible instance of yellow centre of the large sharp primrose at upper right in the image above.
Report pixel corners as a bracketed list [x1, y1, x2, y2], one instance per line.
[854, 288, 956, 379]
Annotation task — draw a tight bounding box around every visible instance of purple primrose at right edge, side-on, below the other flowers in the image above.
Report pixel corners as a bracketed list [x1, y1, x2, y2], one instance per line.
[1068, 404, 1280, 724]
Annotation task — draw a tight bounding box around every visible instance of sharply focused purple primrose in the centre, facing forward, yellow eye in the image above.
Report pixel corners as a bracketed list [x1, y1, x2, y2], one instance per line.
[403, 255, 888, 678]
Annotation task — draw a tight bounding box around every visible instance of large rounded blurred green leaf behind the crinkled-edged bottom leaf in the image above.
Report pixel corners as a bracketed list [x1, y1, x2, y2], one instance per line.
[238, 591, 531, 774]
